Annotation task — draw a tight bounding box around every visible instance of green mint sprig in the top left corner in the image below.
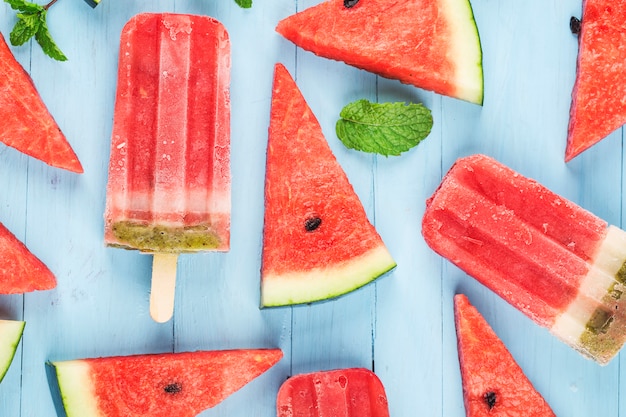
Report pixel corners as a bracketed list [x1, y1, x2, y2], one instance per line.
[4, 0, 67, 61]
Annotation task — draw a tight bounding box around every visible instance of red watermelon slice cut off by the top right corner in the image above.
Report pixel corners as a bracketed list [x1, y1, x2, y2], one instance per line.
[565, 0, 626, 162]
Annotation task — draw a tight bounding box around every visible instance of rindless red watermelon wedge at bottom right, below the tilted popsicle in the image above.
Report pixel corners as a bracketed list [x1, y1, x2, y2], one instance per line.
[454, 294, 555, 417]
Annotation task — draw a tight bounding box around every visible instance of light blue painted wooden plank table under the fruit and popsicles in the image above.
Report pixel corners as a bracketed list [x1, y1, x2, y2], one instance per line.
[0, 0, 626, 417]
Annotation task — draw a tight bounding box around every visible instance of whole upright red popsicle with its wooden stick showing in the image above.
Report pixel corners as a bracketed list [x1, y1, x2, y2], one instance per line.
[104, 13, 231, 322]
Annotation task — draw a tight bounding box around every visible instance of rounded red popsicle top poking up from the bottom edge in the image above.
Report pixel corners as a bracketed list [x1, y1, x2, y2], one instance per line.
[276, 368, 389, 417]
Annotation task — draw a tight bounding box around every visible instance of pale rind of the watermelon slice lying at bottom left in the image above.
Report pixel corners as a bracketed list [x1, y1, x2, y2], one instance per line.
[52, 360, 100, 417]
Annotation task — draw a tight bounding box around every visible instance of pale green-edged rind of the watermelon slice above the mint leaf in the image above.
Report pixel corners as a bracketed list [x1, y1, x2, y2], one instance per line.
[438, 0, 485, 105]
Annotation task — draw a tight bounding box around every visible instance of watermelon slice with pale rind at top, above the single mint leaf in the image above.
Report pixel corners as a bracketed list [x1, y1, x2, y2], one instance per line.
[276, 0, 483, 104]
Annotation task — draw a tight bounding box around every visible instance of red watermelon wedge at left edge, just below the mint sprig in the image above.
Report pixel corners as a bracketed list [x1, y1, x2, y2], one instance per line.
[0, 33, 83, 173]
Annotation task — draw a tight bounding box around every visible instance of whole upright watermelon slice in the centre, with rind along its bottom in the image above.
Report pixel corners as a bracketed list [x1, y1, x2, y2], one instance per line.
[261, 64, 396, 307]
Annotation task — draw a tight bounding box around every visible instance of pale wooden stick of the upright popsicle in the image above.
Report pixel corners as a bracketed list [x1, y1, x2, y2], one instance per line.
[150, 253, 178, 323]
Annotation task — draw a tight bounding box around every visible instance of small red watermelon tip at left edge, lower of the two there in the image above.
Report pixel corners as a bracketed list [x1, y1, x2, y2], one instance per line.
[0, 223, 57, 294]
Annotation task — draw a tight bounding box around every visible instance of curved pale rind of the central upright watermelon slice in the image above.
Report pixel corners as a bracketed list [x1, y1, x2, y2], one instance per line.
[261, 245, 396, 307]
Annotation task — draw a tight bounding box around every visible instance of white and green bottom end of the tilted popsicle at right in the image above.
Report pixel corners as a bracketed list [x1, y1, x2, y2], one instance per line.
[550, 226, 626, 364]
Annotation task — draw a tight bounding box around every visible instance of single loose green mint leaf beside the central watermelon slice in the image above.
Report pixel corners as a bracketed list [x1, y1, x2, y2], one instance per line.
[335, 99, 433, 156]
